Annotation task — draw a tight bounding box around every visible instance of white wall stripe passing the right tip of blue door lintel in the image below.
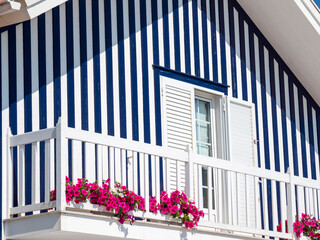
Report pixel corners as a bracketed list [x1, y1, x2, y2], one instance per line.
[223, 1, 232, 96]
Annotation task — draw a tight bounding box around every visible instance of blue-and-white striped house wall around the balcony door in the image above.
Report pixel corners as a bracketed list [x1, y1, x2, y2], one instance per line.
[0, 0, 320, 237]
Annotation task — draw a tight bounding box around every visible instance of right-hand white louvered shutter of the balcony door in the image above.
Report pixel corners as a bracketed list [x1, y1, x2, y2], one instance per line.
[228, 100, 256, 227]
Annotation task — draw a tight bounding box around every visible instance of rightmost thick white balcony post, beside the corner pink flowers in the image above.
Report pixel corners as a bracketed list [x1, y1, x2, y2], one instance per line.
[287, 168, 296, 233]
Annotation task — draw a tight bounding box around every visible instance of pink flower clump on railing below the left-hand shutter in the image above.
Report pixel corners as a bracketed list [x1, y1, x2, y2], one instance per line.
[149, 190, 204, 229]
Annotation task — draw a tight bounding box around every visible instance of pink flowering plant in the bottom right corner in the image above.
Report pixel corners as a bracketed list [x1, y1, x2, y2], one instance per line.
[293, 213, 320, 240]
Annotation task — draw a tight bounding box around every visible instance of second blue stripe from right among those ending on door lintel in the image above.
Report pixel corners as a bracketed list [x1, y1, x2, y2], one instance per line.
[208, 1, 218, 82]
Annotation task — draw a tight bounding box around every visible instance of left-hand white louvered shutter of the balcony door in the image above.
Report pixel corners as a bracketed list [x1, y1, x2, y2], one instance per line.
[163, 80, 194, 191]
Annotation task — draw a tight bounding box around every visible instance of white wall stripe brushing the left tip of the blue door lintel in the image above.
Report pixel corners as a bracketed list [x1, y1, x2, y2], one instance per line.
[146, 1, 156, 144]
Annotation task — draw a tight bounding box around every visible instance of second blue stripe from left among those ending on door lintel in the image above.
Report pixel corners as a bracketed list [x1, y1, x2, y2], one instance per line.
[162, 0, 173, 68]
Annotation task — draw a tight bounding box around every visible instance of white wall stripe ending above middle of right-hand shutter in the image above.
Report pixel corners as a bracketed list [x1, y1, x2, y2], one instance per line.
[233, 8, 243, 99]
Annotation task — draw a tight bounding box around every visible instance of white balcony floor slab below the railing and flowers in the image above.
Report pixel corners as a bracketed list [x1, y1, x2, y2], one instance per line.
[4, 211, 257, 240]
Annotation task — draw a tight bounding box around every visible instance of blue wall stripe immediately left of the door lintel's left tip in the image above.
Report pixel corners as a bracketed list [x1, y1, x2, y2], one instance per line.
[140, 0, 150, 143]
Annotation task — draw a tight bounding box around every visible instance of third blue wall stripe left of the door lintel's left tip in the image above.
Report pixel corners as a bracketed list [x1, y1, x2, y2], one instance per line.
[117, 1, 128, 138]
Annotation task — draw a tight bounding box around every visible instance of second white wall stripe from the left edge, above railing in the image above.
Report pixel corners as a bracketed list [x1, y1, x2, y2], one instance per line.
[16, 24, 25, 134]
